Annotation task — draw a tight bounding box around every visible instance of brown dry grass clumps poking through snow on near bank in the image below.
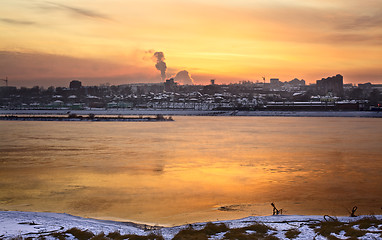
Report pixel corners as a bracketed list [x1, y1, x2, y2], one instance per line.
[8, 216, 382, 240]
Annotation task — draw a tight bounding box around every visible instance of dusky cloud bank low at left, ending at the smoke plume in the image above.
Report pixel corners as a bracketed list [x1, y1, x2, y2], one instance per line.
[0, 51, 158, 87]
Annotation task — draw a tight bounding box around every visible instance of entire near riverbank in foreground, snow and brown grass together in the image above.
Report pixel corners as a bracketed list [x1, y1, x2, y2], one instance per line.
[0, 211, 382, 240]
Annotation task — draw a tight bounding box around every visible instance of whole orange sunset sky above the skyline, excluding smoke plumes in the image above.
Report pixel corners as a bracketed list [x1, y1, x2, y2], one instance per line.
[0, 0, 382, 87]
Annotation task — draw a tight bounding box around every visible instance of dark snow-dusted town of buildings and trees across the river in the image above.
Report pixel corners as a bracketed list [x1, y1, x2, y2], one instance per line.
[0, 75, 382, 111]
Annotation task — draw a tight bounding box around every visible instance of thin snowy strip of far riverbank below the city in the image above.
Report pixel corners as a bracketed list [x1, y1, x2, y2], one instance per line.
[0, 109, 382, 118]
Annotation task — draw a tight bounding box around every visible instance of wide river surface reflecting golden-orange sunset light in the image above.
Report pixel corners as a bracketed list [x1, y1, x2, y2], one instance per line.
[0, 117, 382, 224]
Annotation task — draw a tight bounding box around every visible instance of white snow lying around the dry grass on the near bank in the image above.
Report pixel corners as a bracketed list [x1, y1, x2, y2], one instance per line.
[0, 211, 382, 239]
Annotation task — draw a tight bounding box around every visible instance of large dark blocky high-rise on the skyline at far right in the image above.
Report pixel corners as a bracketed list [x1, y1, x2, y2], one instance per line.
[316, 74, 344, 97]
